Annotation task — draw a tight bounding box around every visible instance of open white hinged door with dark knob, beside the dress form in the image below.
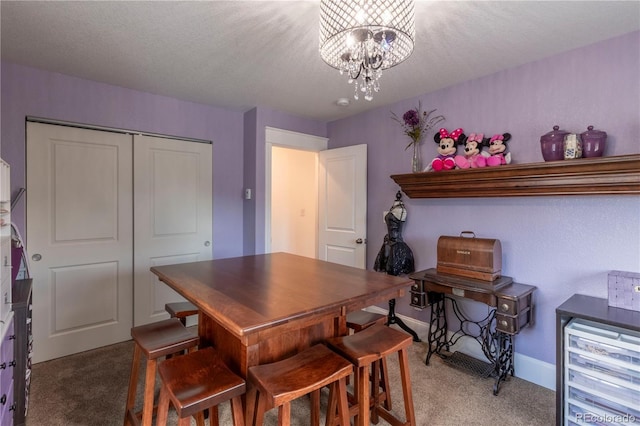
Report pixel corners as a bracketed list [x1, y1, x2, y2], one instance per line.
[318, 145, 367, 269]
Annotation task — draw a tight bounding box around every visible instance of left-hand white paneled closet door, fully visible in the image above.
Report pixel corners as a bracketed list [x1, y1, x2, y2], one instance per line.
[26, 122, 133, 362]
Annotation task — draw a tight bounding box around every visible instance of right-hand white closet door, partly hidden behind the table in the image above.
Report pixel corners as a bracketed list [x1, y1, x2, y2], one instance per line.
[133, 135, 212, 325]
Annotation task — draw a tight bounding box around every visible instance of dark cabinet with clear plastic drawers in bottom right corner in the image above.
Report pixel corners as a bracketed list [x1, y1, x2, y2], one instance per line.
[556, 294, 640, 426]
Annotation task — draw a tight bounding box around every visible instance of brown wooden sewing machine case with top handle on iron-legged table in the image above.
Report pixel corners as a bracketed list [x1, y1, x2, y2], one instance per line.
[436, 231, 502, 281]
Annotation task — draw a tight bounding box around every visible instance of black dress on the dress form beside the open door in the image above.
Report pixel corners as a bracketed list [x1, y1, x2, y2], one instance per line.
[373, 211, 415, 275]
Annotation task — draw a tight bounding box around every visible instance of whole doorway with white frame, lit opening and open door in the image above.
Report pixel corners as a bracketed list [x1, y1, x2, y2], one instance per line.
[265, 127, 367, 269]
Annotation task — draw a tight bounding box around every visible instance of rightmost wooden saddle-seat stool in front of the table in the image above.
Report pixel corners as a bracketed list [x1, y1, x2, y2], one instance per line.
[326, 324, 416, 426]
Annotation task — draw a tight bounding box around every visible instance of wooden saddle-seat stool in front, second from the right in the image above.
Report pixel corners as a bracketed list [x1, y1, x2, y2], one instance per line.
[247, 344, 353, 426]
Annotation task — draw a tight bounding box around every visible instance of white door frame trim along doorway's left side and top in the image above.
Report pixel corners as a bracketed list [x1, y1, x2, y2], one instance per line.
[264, 126, 329, 253]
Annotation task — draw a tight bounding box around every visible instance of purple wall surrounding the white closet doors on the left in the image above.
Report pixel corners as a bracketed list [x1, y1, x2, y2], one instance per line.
[1, 63, 243, 258]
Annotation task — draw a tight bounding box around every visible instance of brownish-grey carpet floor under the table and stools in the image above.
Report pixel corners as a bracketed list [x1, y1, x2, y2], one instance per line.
[27, 334, 555, 426]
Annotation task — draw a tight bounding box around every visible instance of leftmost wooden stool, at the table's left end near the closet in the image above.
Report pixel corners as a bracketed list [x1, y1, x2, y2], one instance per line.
[124, 318, 199, 426]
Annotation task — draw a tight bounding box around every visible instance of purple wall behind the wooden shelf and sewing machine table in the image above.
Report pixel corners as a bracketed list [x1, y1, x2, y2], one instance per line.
[328, 32, 640, 363]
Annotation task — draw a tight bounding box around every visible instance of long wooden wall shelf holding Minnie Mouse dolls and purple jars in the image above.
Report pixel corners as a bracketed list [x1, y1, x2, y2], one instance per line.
[391, 154, 640, 198]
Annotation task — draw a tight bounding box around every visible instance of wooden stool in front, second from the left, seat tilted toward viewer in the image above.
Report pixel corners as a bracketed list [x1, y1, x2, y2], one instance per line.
[157, 347, 246, 426]
